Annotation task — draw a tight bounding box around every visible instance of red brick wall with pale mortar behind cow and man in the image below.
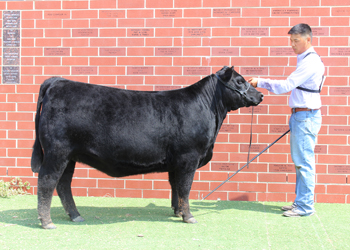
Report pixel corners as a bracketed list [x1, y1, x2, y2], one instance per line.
[0, 0, 350, 203]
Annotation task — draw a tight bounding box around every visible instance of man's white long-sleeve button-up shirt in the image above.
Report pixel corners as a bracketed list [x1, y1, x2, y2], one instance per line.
[257, 47, 325, 109]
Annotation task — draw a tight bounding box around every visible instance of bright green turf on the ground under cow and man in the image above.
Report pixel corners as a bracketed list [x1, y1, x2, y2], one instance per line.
[0, 196, 350, 250]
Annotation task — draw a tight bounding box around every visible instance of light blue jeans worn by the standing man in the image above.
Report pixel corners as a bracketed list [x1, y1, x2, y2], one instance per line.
[289, 110, 322, 215]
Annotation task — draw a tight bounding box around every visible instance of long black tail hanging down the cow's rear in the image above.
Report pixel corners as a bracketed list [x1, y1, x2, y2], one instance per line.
[31, 79, 51, 173]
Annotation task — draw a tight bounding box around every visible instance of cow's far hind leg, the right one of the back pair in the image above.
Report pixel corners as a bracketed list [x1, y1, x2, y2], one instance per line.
[56, 161, 84, 222]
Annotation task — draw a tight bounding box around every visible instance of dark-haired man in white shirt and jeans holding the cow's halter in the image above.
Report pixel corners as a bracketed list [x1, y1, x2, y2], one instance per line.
[248, 23, 325, 217]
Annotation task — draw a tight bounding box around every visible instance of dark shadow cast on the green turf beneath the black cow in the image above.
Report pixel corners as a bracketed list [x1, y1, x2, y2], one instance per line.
[0, 200, 281, 228]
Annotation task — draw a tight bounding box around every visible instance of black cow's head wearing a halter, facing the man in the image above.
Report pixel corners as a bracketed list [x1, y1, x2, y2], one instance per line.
[215, 66, 264, 110]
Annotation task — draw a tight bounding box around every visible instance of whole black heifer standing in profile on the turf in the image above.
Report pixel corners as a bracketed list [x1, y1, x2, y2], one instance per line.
[31, 67, 263, 229]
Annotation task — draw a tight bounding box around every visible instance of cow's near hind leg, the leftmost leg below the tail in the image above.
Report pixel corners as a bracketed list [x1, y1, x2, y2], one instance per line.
[38, 155, 67, 229]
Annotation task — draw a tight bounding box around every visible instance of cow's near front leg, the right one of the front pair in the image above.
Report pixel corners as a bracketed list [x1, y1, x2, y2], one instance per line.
[175, 170, 197, 223]
